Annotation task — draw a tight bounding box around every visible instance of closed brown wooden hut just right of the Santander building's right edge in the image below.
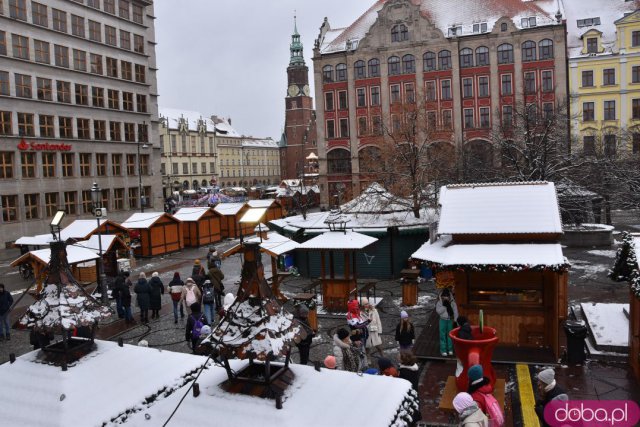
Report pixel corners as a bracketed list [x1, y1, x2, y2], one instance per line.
[173, 207, 222, 247]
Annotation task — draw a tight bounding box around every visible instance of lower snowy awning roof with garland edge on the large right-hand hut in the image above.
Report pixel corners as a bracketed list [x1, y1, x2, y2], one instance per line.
[411, 236, 566, 266]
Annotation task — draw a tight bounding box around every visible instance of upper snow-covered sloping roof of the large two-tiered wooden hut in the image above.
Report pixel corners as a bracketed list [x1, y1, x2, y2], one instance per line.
[438, 182, 562, 234]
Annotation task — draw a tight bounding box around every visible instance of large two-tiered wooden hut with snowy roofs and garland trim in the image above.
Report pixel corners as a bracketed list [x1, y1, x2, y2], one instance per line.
[413, 182, 568, 360]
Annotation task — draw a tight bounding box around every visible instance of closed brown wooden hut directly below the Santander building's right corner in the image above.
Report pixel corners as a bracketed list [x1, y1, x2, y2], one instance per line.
[122, 212, 184, 257]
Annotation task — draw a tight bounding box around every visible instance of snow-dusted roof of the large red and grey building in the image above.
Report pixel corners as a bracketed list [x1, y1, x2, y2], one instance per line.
[320, 0, 560, 54]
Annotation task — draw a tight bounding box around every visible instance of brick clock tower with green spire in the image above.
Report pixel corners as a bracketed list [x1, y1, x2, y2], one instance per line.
[280, 18, 317, 179]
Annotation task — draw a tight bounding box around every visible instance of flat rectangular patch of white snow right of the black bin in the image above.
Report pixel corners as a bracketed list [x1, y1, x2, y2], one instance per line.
[580, 303, 629, 347]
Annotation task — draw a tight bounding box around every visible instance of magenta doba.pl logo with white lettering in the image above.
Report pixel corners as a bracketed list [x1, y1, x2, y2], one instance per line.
[544, 400, 640, 427]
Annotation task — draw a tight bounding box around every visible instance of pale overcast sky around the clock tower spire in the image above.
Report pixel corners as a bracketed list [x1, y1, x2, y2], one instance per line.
[155, 0, 374, 140]
